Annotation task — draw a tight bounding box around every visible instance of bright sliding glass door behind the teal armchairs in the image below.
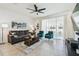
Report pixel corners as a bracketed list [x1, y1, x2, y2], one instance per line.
[41, 16, 64, 39]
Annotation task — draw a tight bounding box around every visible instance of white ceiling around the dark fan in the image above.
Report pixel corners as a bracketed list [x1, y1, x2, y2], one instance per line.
[0, 3, 75, 17]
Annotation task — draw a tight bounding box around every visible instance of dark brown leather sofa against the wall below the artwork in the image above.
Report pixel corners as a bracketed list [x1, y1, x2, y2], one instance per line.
[8, 30, 28, 44]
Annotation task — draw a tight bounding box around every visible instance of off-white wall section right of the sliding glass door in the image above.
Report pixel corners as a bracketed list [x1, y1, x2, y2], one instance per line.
[64, 15, 75, 39]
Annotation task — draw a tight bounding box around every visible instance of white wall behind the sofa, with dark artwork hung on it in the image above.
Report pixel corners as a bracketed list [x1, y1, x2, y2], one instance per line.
[0, 8, 34, 41]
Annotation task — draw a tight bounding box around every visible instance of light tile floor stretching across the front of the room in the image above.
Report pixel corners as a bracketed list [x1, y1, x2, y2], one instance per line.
[0, 39, 68, 56]
